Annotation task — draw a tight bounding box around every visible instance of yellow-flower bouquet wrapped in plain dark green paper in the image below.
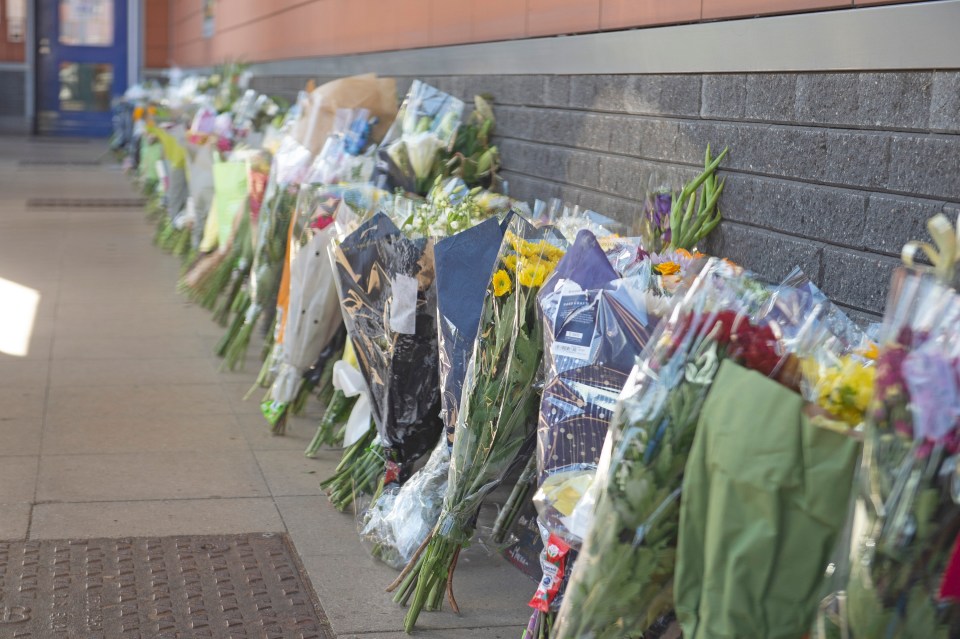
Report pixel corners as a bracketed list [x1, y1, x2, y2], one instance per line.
[673, 278, 872, 639]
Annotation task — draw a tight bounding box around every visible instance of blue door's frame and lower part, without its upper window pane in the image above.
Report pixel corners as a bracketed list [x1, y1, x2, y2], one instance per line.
[34, 0, 127, 137]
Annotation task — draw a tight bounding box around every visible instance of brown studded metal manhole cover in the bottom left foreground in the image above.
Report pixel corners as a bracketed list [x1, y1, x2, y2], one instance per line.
[0, 533, 334, 639]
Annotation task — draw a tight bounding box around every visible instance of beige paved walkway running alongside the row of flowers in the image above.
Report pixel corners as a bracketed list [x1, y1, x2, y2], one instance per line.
[0, 137, 535, 639]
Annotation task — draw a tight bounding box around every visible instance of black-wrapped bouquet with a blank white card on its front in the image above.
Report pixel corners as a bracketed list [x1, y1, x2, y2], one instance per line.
[324, 213, 442, 508]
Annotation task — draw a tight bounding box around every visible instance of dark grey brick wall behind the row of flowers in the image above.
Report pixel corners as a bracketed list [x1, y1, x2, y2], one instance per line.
[256, 71, 960, 316]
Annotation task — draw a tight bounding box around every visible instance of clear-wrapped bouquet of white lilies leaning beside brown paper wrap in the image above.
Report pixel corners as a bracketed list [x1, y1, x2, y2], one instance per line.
[373, 80, 463, 194]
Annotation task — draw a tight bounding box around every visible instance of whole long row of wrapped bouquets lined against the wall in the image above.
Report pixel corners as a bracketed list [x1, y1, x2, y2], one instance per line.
[114, 65, 960, 638]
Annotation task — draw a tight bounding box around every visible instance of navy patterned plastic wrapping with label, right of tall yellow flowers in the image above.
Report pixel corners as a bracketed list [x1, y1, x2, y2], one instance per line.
[534, 231, 660, 547]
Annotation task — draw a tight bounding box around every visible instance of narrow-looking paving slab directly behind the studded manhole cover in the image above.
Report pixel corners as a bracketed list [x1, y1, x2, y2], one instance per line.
[30, 497, 283, 539]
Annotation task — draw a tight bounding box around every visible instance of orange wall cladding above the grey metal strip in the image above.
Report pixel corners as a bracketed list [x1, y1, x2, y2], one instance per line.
[171, 0, 922, 67]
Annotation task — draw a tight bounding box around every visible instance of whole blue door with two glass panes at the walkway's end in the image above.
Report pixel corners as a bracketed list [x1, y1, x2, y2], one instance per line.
[36, 0, 127, 137]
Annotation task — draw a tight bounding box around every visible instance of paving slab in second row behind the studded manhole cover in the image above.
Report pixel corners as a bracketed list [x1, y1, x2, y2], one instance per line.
[37, 451, 270, 502]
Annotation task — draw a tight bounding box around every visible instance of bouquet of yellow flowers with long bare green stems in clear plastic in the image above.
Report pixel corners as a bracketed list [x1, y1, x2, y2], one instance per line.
[391, 217, 565, 632]
